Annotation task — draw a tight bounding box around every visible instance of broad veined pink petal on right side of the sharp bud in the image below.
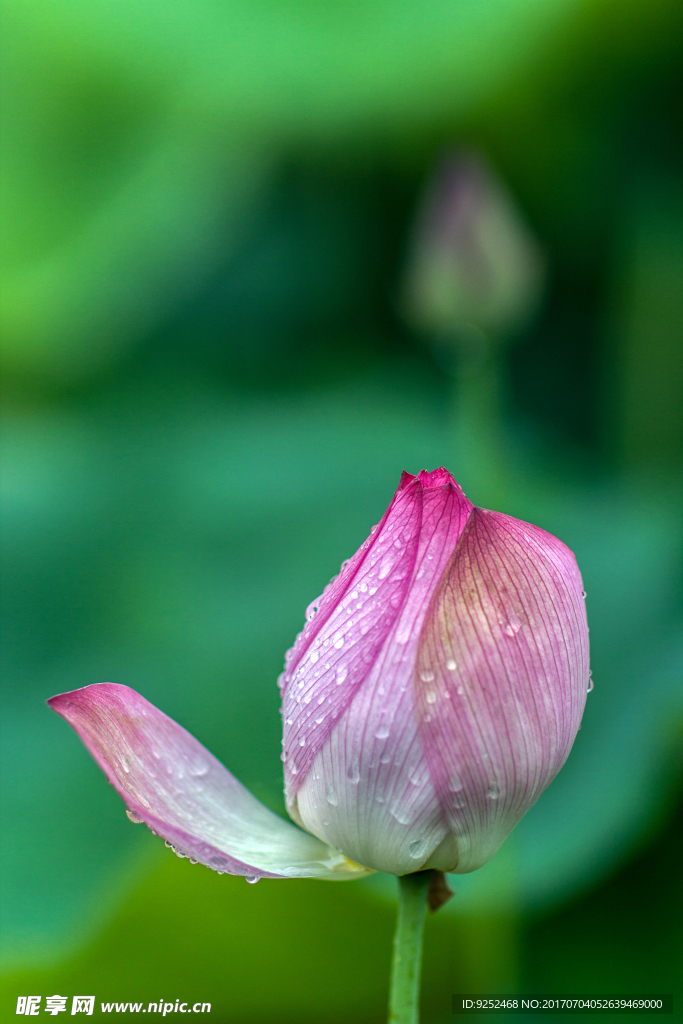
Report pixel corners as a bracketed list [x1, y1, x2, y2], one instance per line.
[415, 509, 589, 872]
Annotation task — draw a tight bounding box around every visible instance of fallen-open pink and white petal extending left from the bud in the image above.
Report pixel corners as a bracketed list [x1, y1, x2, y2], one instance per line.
[48, 683, 367, 881]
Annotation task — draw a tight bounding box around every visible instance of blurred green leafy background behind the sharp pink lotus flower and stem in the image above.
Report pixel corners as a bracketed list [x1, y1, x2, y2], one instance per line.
[1, 0, 683, 1024]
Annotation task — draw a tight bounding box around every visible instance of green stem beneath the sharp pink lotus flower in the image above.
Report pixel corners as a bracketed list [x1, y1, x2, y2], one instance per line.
[389, 871, 431, 1024]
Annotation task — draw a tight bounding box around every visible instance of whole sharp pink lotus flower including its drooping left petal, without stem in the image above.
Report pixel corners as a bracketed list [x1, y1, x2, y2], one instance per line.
[49, 469, 589, 882]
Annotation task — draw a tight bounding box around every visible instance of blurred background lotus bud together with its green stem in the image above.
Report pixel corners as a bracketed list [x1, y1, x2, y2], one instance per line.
[402, 152, 545, 507]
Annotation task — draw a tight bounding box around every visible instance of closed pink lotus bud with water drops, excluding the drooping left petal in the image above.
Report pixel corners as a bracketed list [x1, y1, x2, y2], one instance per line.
[282, 469, 589, 874]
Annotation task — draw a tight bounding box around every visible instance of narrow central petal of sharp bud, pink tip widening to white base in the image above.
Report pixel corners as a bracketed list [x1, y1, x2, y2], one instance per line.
[291, 471, 472, 874]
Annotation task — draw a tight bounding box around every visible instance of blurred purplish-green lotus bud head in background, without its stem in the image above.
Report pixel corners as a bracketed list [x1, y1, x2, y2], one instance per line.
[405, 154, 544, 337]
